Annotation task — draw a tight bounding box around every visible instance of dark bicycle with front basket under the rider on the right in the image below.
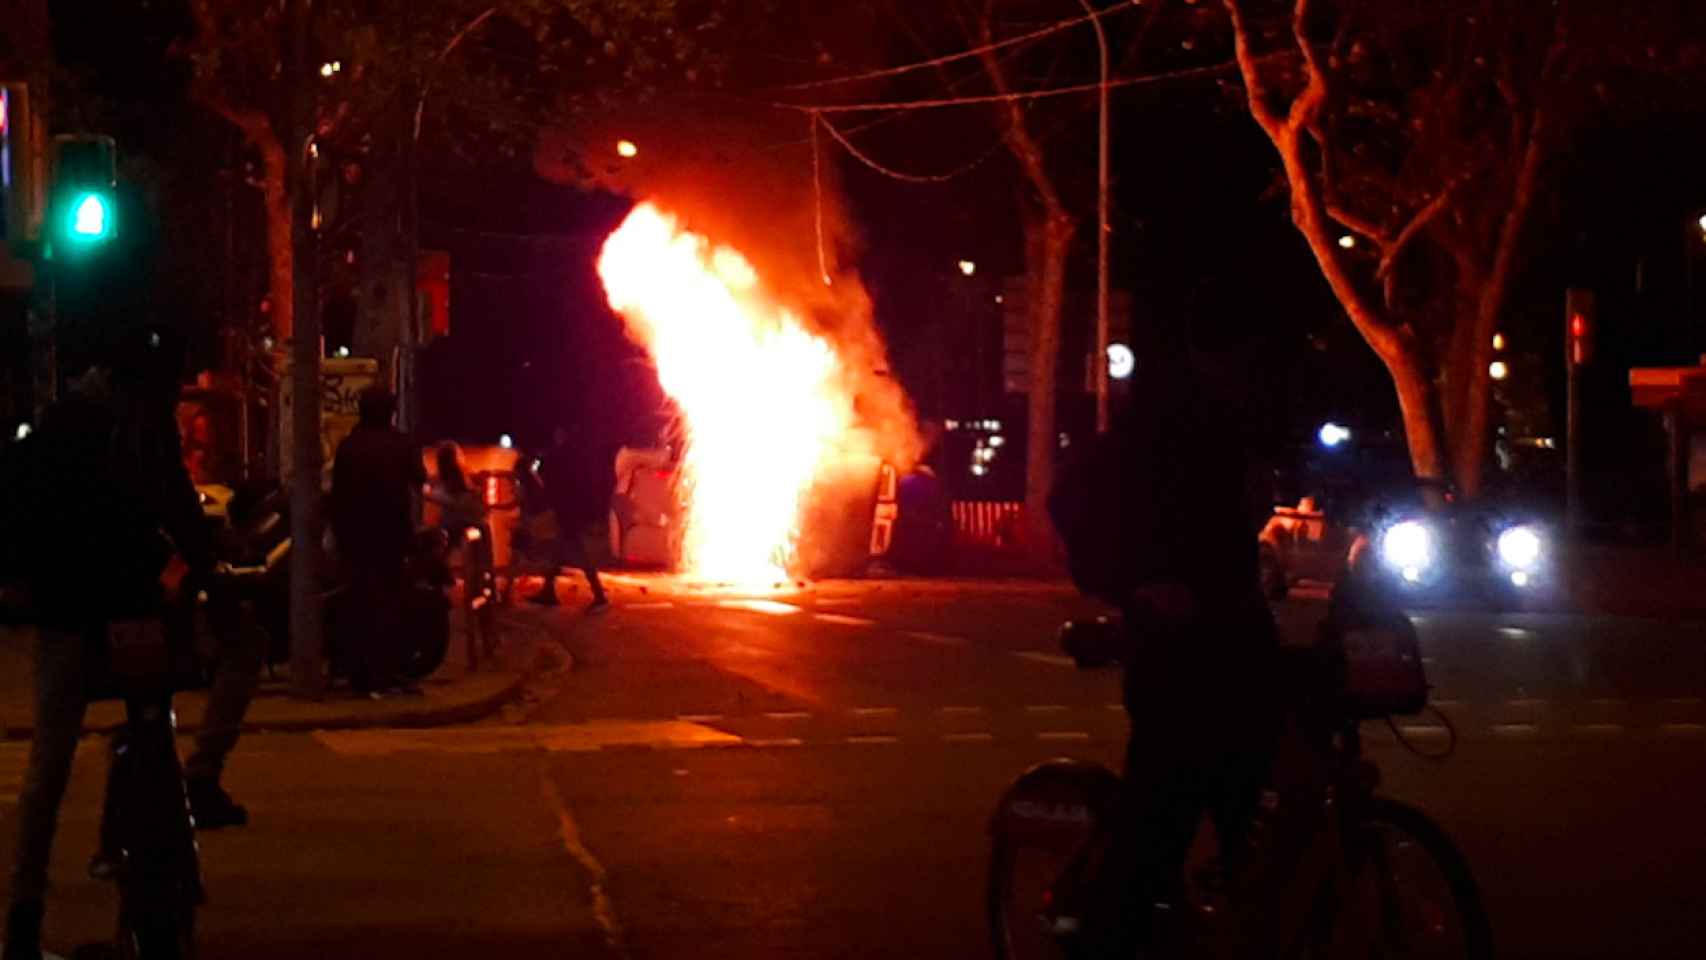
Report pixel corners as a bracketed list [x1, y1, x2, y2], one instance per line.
[988, 603, 1493, 960]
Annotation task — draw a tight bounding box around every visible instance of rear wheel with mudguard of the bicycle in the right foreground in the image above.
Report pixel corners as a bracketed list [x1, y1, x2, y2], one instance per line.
[986, 760, 1119, 960]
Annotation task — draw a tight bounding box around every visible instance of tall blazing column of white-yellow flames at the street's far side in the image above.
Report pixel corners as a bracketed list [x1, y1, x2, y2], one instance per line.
[599, 203, 853, 585]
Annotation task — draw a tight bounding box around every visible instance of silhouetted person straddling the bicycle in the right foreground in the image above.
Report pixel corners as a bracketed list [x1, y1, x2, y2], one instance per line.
[1049, 334, 1276, 960]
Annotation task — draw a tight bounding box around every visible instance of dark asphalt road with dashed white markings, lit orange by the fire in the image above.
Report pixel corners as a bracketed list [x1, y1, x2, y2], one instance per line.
[0, 583, 1706, 960]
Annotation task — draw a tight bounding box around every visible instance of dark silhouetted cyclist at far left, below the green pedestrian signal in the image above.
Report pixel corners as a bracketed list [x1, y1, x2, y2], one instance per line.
[5, 327, 225, 960]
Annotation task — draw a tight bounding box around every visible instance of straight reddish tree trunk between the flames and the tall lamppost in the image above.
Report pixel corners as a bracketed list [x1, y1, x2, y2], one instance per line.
[1025, 208, 1075, 556]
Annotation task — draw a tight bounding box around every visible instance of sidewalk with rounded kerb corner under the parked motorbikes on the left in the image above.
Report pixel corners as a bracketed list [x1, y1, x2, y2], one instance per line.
[0, 610, 549, 740]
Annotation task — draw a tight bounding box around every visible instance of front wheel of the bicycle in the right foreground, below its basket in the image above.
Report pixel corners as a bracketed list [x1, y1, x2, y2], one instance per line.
[1307, 798, 1493, 960]
